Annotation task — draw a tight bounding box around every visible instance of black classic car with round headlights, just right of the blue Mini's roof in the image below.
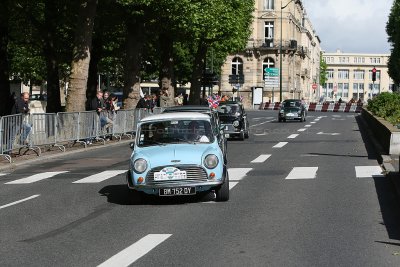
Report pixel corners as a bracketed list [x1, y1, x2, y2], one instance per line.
[217, 101, 250, 140]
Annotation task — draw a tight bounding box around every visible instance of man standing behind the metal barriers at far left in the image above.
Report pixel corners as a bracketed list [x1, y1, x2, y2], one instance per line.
[11, 92, 32, 145]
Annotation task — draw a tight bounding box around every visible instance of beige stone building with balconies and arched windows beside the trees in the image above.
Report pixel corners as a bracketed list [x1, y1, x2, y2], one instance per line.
[220, 0, 321, 108]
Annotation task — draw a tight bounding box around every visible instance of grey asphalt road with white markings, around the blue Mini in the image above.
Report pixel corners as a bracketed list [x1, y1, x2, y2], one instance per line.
[0, 111, 400, 266]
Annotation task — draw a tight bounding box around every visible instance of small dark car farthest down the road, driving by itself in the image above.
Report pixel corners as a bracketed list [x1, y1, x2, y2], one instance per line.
[278, 99, 307, 122]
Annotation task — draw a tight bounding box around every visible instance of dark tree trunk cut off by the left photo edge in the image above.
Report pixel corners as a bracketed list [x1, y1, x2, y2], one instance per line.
[0, 1, 12, 116]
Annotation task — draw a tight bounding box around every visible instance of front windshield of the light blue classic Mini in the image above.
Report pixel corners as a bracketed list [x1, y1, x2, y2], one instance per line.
[138, 119, 214, 146]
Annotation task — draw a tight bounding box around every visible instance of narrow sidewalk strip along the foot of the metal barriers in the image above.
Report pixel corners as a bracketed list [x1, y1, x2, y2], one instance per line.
[0, 139, 134, 173]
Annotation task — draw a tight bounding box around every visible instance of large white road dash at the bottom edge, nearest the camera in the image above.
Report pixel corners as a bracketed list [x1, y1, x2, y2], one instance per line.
[98, 234, 171, 267]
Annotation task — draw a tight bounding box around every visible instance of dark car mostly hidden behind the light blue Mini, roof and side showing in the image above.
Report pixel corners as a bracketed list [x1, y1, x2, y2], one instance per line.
[162, 105, 228, 162]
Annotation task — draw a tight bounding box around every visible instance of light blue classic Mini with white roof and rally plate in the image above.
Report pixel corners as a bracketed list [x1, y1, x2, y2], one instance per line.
[127, 112, 229, 202]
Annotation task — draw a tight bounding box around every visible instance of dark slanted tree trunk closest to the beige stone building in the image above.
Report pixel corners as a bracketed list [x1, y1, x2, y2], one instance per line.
[189, 42, 207, 105]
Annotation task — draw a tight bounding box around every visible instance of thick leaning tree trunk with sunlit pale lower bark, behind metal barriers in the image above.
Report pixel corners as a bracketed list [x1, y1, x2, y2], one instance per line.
[66, 0, 97, 112]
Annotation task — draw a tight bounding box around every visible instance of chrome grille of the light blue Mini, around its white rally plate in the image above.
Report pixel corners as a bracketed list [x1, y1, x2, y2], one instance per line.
[146, 165, 208, 184]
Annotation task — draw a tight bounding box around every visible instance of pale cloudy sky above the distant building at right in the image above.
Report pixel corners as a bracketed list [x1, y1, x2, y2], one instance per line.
[302, 0, 393, 54]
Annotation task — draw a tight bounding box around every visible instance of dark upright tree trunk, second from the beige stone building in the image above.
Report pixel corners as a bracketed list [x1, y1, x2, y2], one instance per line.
[159, 33, 175, 99]
